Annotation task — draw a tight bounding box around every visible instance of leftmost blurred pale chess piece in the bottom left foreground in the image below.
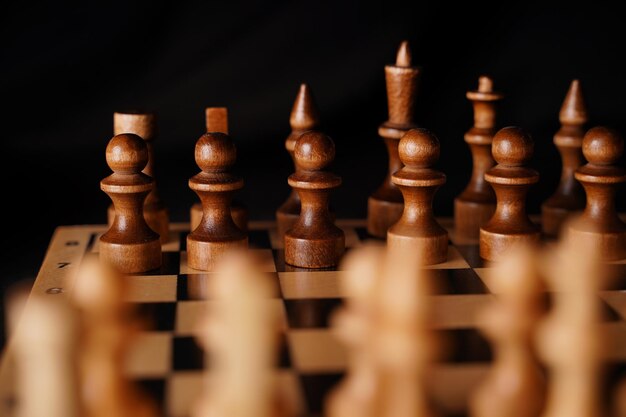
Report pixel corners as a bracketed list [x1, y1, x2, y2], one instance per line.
[10, 294, 78, 417]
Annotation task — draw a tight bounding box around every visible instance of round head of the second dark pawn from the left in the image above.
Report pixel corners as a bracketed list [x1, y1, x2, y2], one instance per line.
[195, 132, 237, 172]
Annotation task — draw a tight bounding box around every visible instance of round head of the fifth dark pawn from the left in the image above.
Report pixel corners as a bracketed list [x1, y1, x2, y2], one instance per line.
[491, 126, 535, 167]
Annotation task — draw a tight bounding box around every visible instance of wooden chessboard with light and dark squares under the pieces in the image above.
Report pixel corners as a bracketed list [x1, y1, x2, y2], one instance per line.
[0, 219, 626, 417]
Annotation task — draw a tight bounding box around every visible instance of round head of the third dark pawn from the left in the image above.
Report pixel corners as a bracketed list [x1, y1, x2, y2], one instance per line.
[294, 130, 335, 171]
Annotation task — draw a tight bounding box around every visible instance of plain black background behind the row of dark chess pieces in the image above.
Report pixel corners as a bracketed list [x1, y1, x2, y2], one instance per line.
[0, 1, 626, 342]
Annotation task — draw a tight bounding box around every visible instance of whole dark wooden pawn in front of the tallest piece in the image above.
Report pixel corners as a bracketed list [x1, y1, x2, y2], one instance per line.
[387, 128, 448, 265]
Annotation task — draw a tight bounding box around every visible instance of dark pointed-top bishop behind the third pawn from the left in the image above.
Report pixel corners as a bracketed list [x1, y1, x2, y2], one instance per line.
[276, 83, 320, 237]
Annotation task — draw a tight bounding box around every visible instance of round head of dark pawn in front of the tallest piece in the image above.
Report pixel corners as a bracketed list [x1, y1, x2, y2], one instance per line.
[398, 128, 440, 168]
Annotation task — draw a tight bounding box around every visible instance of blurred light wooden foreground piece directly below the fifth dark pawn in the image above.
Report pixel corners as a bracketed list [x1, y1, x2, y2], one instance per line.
[470, 248, 545, 417]
